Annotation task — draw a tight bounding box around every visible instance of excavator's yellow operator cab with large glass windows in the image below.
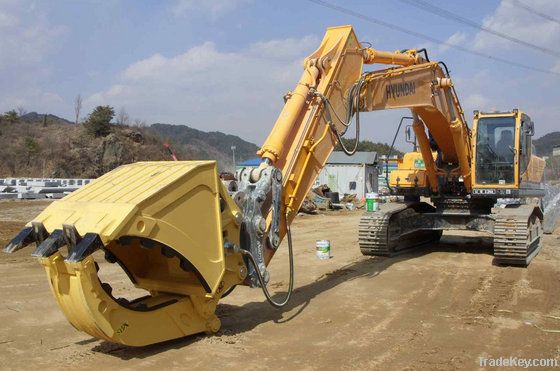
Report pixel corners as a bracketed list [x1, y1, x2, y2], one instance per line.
[472, 109, 544, 198]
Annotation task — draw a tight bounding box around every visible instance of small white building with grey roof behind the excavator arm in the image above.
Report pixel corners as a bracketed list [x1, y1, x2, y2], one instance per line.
[315, 152, 379, 199]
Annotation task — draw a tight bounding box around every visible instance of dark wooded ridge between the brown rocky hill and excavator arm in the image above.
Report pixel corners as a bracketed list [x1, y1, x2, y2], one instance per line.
[149, 123, 258, 169]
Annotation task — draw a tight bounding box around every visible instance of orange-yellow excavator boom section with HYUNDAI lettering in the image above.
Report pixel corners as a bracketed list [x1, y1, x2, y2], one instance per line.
[361, 61, 471, 194]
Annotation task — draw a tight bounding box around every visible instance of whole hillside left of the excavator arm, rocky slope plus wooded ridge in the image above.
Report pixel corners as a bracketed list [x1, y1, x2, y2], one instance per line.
[0, 112, 257, 178]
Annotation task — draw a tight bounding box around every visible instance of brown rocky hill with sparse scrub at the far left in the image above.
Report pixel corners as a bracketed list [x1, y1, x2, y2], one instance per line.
[0, 117, 169, 178]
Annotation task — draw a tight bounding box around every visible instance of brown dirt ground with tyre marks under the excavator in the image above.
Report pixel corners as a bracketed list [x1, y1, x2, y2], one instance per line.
[0, 202, 560, 370]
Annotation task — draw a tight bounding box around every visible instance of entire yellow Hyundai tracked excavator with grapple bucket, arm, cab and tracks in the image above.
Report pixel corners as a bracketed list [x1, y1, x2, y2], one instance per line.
[6, 26, 544, 346]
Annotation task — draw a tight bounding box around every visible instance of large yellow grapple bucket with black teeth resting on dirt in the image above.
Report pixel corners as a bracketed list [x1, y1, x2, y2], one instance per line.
[7, 161, 241, 345]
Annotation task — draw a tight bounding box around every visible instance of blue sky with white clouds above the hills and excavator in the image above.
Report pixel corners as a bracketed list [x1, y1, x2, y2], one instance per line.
[0, 0, 560, 150]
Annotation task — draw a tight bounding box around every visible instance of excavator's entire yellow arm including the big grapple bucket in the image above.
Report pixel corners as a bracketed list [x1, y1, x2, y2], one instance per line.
[6, 26, 470, 346]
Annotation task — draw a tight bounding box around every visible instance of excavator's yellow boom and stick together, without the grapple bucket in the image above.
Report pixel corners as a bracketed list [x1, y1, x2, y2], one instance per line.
[254, 26, 471, 274]
